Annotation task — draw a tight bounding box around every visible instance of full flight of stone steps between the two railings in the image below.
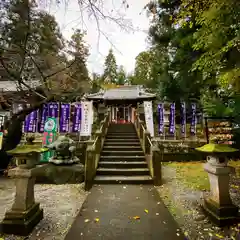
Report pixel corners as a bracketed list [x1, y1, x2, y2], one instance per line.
[94, 124, 153, 184]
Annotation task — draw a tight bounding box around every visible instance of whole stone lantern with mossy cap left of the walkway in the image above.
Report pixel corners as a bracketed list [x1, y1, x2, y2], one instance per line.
[0, 138, 48, 236]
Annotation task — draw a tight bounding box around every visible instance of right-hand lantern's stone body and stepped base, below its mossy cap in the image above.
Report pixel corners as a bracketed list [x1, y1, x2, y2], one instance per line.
[202, 156, 239, 226]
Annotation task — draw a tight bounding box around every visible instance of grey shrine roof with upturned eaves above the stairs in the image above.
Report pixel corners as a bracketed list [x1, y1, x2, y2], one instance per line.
[86, 85, 156, 100]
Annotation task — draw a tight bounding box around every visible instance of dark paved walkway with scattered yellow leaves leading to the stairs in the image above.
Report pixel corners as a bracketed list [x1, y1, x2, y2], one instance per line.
[65, 184, 185, 240]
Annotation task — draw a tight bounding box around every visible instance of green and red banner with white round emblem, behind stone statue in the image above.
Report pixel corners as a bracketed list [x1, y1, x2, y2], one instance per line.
[41, 118, 57, 162]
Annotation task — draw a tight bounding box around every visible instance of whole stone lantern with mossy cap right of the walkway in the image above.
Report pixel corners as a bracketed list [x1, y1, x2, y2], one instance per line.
[196, 143, 239, 226]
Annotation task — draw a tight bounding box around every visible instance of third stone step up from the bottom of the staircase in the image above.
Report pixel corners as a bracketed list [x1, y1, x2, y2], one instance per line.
[98, 161, 147, 168]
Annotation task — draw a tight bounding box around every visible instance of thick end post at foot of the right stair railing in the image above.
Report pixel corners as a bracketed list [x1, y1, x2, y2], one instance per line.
[152, 146, 162, 186]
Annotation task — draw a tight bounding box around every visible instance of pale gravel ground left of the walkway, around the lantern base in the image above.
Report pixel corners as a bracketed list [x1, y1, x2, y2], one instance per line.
[0, 178, 88, 240]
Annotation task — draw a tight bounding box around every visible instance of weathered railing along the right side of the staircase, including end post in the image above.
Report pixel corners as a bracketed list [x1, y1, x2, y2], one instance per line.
[134, 114, 162, 186]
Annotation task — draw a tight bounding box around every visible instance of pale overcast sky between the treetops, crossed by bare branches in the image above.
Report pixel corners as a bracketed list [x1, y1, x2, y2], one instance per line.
[43, 0, 149, 73]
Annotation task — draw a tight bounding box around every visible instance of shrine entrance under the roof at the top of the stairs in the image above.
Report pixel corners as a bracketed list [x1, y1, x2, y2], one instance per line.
[111, 105, 134, 123]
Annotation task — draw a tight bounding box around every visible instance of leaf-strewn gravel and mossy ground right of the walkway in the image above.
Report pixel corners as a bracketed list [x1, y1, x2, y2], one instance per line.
[157, 161, 240, 240]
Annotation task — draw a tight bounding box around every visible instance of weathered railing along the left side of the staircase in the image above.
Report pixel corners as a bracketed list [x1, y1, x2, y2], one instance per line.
[84, 109, 110, 190]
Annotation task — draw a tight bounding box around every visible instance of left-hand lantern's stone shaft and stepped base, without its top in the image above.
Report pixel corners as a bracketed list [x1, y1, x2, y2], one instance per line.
[0, 167, 43, 236]
